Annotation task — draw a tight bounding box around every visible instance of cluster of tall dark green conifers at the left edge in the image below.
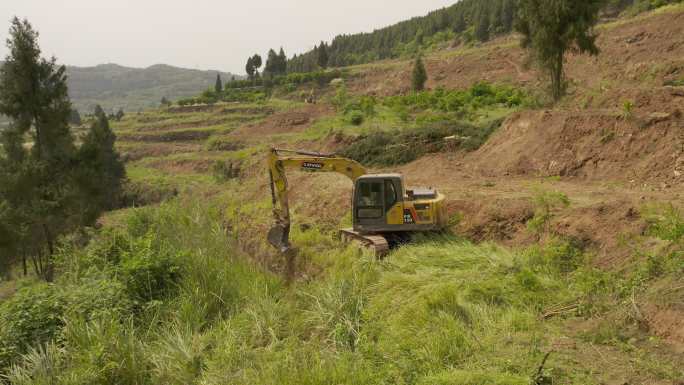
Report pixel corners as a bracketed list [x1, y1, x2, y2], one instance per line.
[0, 18, 125, 280]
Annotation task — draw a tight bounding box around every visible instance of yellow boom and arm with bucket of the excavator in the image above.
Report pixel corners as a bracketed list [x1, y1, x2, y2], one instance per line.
[268, 148, 366, 253]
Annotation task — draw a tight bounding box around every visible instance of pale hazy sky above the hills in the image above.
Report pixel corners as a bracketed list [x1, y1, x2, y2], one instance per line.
[0, 0, 456, 73]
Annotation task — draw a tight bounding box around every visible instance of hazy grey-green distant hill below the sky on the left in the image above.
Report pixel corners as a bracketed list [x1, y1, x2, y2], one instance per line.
[67, 64, 240, 113]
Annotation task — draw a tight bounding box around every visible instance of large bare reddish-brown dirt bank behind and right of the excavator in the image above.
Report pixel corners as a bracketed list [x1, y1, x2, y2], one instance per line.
[464, 110, 684, 184]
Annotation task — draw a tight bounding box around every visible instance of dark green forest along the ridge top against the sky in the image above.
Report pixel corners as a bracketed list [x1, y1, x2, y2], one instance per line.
[288, 0, 681, 72]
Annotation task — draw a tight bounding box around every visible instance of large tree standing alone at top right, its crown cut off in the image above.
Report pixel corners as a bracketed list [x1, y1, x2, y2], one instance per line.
[516, 0, 603, 101]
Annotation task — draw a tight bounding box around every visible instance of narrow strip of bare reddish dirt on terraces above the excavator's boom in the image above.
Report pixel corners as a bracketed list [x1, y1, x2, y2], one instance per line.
[231, 104, 335, 137]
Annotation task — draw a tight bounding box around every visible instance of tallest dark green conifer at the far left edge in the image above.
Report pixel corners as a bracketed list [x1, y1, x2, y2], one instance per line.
[0, 18, 78, 280]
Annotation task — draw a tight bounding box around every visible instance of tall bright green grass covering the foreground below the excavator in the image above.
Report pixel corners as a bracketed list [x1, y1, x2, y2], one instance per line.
[3, 199, 676, 385]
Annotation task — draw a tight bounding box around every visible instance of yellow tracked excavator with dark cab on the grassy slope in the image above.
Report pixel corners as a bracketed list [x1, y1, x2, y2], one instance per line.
[268, 148, 448, 256]
